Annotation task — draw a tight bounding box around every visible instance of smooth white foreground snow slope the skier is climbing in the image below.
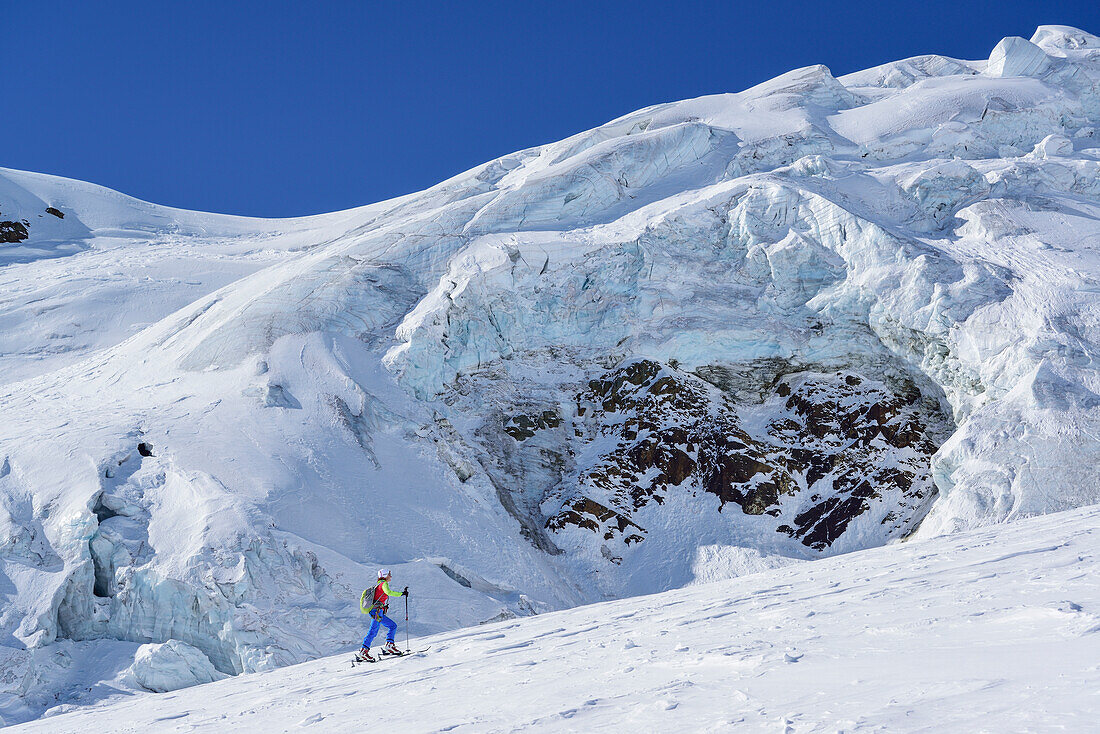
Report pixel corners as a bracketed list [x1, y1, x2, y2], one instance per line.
[13, 505, 1100, 734]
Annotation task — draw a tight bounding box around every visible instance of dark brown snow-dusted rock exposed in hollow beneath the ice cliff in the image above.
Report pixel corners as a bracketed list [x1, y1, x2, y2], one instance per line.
[545, 360, 945, 550]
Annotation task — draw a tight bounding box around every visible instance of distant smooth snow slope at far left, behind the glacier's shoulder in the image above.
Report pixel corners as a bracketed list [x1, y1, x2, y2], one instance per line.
[0, 168, 369, 383]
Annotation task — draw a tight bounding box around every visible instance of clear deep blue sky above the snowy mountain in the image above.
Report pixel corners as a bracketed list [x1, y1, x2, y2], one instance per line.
[8, 0, 1100, 216]
